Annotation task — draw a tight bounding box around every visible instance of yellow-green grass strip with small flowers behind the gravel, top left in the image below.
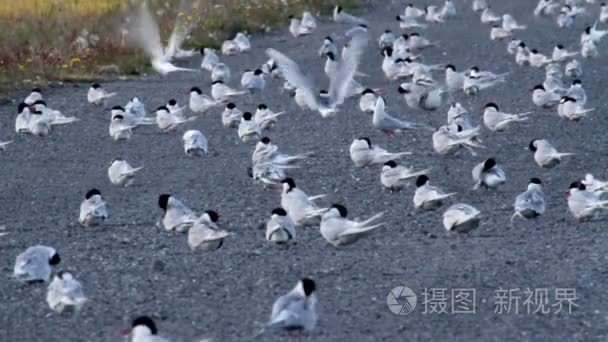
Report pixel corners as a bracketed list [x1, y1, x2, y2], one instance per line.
[0, 0, 358, 94]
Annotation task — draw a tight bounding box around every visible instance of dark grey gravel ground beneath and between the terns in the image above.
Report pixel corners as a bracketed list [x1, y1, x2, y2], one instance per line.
[0, 0, 608, 342]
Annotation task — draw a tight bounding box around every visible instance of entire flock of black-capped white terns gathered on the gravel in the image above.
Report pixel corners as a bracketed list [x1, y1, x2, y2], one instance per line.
[5, 0, 608, 342]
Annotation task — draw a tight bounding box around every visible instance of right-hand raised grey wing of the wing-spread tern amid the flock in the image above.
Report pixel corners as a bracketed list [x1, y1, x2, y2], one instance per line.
[329, 32, 368, 106]
